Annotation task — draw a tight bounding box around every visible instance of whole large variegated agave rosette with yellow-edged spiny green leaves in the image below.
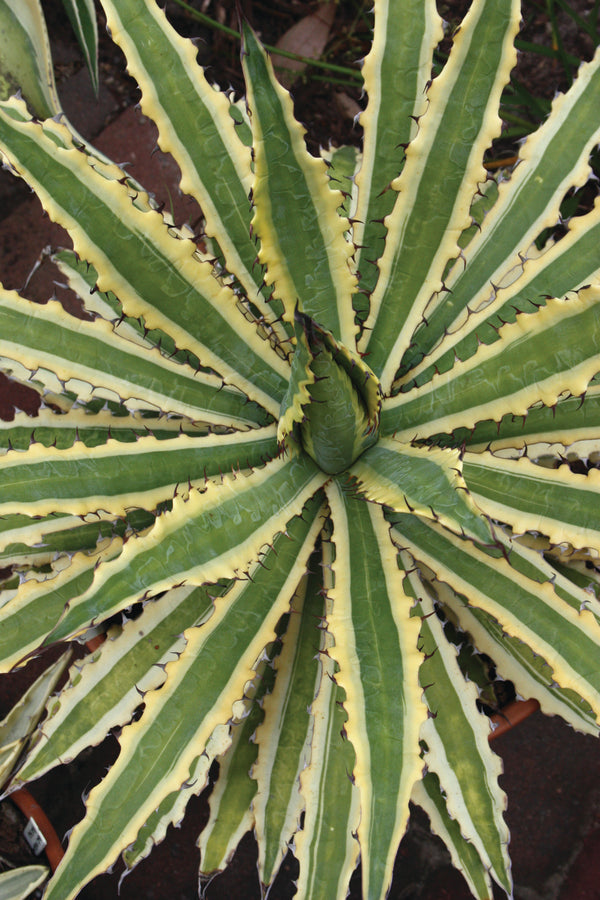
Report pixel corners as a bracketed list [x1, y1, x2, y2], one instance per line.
[0, 0, 600, 900]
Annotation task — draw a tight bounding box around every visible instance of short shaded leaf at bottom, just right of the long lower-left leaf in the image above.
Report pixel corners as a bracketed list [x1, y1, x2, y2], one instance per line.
[198, 659, 274, 873]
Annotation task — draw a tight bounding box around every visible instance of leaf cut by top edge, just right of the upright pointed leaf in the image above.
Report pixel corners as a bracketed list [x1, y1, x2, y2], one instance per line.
[353, 0, 443, 293]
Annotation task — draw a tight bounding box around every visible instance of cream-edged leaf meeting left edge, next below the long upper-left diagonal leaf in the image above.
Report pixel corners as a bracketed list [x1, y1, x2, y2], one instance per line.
[0, 289, 260, 427]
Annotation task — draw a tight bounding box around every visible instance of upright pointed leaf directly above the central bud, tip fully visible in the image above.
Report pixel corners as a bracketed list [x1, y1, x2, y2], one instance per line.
[242, 25, 356, 347]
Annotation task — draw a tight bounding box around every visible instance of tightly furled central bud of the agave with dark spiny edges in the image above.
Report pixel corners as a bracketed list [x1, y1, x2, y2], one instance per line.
[278, 313, 381, 475]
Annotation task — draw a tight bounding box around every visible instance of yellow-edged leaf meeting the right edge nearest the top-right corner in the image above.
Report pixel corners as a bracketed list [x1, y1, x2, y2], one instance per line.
[403, 44, 600, 369]
